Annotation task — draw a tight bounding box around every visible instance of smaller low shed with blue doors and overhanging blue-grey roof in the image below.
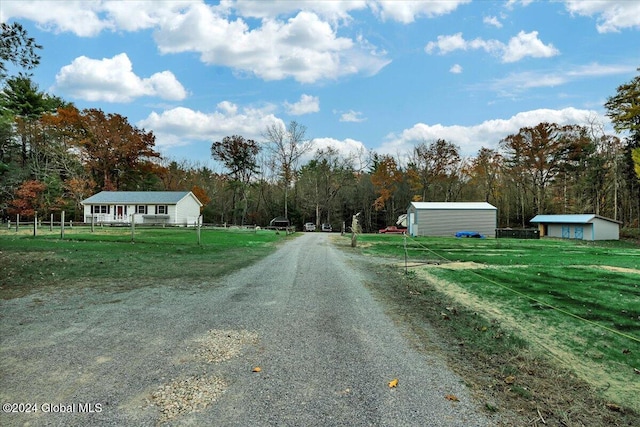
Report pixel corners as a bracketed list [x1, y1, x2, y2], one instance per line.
[529, 214, 620, 240]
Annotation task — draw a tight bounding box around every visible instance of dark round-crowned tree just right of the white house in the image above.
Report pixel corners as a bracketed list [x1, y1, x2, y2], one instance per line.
[211, 135, 260, 224]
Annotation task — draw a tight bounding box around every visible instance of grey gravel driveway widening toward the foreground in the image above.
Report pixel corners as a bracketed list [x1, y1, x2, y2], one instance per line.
[0, 233, 492, 426]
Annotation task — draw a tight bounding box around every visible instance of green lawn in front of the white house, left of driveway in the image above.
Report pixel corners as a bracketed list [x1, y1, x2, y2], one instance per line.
[0, 227, 294, 299]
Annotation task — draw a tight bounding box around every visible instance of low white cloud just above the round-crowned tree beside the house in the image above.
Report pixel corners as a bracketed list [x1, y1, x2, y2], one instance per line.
[136, 101, 285, 148]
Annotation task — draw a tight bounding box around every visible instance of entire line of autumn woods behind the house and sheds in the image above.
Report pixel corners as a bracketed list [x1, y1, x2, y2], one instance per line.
[0, 24, 640, 231]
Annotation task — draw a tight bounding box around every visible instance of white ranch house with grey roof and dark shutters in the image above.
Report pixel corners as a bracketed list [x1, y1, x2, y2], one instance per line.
[81, 191, 202, 226]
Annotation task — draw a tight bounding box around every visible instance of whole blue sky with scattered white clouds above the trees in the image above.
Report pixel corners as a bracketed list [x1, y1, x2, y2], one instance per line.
[0, 0, 640, 169]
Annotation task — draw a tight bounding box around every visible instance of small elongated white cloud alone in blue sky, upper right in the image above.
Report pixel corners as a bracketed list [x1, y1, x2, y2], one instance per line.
[424, 31, 560, 62]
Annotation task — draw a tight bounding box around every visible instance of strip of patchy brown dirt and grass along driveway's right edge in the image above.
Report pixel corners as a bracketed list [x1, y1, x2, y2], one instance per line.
[364, 266, 640, 427]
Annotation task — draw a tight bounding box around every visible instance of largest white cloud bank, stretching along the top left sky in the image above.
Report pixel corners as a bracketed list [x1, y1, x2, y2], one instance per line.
[2, 0, 390, 83]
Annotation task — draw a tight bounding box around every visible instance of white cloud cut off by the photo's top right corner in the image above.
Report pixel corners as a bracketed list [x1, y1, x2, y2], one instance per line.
[565, 0, 640, 33]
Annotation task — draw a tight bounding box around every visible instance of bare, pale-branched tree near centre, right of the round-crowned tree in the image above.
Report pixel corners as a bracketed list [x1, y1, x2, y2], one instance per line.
[263, 121, 313, 218]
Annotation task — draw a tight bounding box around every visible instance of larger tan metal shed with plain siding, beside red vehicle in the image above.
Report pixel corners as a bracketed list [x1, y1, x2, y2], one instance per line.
[407, 202, 498, 237]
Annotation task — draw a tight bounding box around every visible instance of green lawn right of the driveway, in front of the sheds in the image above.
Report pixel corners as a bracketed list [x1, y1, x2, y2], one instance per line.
[352, 235, 640, 411]
